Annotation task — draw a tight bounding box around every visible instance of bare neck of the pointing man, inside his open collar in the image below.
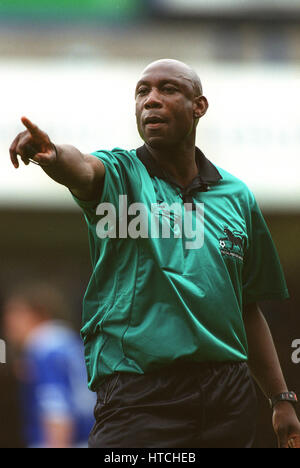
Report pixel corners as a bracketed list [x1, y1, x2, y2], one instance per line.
[146, 143, 198, 187]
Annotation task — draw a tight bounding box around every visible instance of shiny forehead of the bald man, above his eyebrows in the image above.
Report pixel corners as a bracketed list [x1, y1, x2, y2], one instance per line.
[137, 63, 194, 88]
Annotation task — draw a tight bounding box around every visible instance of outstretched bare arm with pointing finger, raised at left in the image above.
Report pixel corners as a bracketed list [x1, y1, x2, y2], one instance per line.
[10, 117, 105, 200]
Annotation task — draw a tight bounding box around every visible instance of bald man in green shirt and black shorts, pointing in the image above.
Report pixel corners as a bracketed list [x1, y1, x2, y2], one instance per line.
[10, 60, 300, 448]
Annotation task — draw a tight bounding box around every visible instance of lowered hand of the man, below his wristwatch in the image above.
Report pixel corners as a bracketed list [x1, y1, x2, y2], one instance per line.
[273, 401, 300, 448]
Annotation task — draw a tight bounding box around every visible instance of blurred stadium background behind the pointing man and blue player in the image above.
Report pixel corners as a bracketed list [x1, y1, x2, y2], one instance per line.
[0, 0, 300, 447]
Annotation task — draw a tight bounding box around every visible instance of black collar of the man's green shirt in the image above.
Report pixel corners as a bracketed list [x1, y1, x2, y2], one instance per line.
[136, 145, 222, 193]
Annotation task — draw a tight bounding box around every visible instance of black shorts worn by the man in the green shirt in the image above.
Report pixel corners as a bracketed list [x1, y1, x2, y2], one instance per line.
[89, 362, 256, 448]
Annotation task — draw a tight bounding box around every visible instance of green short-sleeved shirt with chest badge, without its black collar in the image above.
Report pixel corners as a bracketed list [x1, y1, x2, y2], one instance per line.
[74, 146, 288, 391]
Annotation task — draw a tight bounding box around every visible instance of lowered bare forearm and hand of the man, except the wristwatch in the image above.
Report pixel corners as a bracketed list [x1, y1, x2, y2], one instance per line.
[244, 303, 300, 448]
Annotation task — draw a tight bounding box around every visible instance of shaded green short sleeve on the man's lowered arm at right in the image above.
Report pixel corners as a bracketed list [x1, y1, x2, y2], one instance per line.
[243, 194, 289, 305]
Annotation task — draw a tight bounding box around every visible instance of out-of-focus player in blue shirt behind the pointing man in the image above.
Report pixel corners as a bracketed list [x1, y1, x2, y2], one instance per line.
[3, 284, 95, 448]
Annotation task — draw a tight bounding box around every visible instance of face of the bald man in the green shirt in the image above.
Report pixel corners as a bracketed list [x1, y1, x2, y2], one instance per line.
[135, 63, 205, 148]
